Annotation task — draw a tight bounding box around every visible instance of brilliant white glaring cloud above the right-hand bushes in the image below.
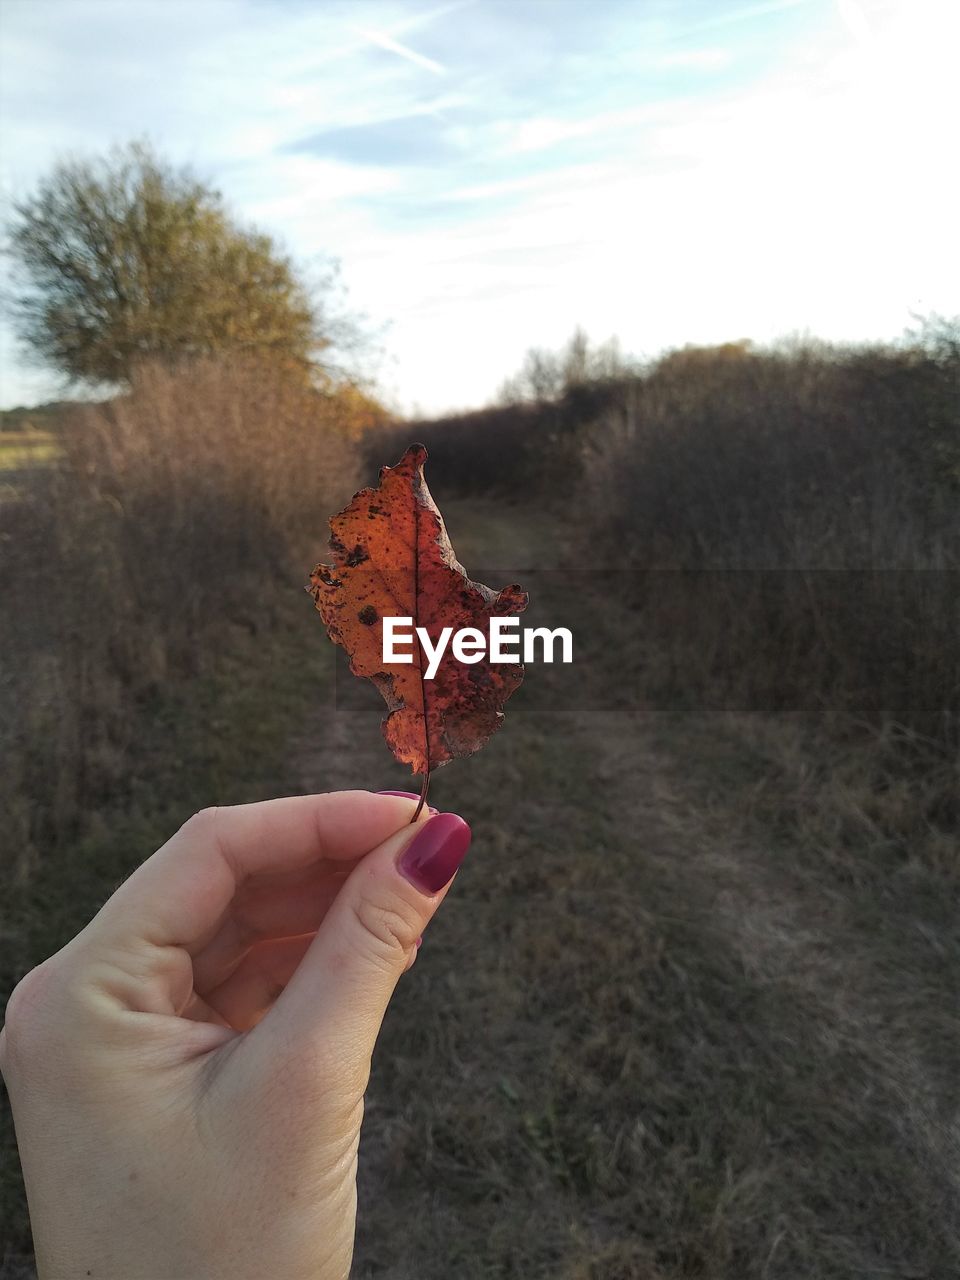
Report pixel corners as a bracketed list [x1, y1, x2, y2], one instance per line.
[363, 6, 960, 407]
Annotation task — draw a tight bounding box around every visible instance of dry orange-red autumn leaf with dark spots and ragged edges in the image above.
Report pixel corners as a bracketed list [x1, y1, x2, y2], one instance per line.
[310, 444, 527, 781]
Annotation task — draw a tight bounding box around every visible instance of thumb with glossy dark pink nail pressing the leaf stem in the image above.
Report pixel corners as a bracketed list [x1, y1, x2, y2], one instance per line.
[255, 813, 470, 1065]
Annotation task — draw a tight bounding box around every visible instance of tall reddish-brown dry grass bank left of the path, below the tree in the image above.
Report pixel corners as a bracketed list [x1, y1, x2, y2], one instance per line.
[0, 361, 369, 1272]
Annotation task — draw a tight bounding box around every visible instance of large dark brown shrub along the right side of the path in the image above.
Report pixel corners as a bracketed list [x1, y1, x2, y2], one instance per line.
[585, 346, 960, 750]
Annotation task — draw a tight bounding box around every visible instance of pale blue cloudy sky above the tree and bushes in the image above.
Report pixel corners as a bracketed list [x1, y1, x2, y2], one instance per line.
[0, 0, 960, 413]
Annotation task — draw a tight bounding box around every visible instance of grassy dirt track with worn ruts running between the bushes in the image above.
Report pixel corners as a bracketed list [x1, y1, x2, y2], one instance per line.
[289, 503, 960, 1280]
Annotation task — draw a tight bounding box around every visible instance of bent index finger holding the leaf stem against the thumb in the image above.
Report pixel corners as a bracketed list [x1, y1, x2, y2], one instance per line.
[95, 791, 426, 946]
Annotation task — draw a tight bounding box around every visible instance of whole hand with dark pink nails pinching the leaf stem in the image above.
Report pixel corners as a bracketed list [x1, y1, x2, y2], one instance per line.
[0, 791, 470, 1280]
